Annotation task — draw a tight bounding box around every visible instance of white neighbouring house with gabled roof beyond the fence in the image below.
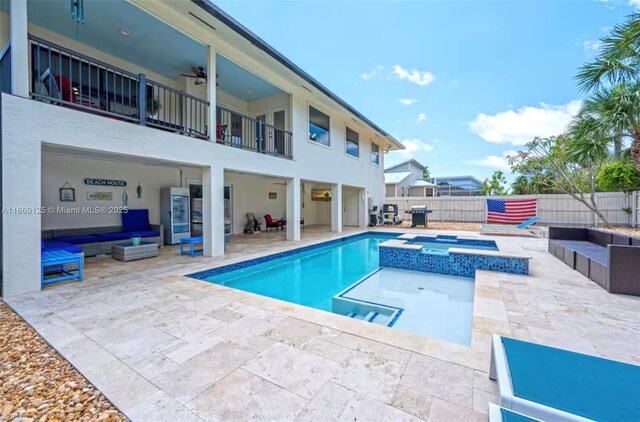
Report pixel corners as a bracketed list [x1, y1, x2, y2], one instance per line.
[384, 159, 435, 198]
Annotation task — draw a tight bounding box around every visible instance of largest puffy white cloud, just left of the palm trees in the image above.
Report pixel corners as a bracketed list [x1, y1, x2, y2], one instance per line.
[469, 100, 584, 145]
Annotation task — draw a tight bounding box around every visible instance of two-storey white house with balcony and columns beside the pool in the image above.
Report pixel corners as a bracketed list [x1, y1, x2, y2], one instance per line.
[0, 0, 403, 295]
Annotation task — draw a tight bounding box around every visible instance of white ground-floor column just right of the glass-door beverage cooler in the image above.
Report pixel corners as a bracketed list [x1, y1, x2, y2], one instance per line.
[202, 167, 224, 256]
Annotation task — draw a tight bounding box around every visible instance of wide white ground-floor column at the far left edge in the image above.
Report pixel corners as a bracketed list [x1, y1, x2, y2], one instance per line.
[2, 131, 40, 296]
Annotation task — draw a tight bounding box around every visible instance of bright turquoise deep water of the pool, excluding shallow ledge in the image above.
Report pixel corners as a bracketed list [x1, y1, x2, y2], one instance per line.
[204, 235, 390, 312]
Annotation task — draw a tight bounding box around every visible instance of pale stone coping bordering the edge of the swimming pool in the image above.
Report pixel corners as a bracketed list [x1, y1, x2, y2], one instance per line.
[182, 228, 529, 372]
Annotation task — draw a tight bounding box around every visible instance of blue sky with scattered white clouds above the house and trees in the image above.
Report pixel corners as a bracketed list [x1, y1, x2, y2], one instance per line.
[216, 0, 640, 181]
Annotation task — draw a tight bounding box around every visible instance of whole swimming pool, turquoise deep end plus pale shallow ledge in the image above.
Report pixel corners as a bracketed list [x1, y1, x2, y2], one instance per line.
[190, 233, 474, 344]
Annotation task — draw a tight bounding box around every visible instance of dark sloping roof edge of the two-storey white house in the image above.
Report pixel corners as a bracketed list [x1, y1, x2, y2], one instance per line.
[191, 0, 404, 149]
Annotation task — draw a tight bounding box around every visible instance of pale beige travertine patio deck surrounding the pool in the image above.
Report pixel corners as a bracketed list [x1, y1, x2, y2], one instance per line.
[7, 227, 640, 421]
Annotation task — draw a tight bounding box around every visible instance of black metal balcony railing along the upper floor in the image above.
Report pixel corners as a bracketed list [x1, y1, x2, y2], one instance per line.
[25, 36, 292, 158]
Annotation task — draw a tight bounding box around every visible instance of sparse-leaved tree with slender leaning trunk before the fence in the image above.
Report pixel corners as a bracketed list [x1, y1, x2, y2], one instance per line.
[508, 134, 610, 226]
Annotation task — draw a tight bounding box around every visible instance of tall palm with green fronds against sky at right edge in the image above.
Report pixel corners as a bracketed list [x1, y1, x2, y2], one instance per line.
[576, 13, 640, 170]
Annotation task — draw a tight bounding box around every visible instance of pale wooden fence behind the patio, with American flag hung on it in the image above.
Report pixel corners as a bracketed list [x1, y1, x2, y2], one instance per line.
[385, 192, 640, 227]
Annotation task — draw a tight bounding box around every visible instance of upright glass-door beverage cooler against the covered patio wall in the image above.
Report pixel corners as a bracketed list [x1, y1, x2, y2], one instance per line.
[160, 188, 191, 245]
